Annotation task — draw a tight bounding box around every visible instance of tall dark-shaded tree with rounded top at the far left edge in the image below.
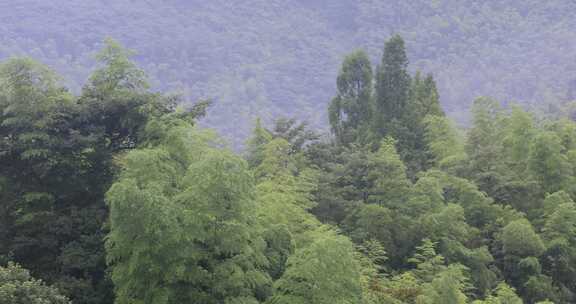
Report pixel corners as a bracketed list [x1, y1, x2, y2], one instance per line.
[0, 59, 111, 302]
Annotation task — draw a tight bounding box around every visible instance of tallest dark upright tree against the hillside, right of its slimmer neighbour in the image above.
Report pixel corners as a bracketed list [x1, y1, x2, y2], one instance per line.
[372, 35, 444, 178]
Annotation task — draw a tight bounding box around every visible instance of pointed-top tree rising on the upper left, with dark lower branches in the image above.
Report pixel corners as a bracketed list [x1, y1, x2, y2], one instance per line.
[79, 39, 178, 152]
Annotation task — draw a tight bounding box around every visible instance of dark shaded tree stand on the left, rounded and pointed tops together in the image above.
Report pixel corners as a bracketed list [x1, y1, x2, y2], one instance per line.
[0, 40, 207, 303]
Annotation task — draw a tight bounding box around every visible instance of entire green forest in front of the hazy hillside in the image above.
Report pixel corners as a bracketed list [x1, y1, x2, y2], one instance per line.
[0, 35, 576, 304]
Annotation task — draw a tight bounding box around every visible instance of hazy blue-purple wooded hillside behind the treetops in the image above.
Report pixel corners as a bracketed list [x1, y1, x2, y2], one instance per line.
[0, 0, 576, 144]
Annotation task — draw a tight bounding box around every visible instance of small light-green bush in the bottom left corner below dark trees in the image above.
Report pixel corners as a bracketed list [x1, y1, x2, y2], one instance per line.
[0, 263, 71, 304]
